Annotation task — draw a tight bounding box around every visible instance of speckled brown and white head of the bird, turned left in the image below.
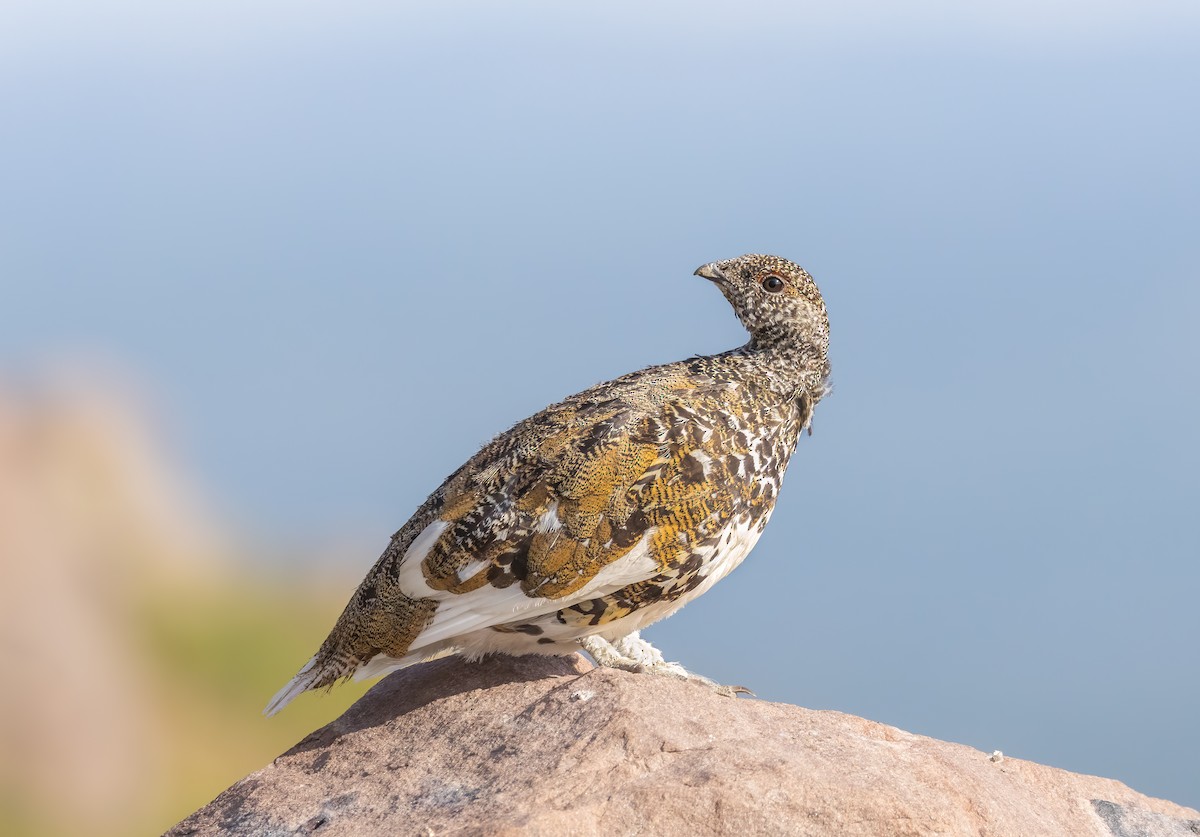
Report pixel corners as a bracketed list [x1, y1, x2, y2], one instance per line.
[696, 253, 829, 359]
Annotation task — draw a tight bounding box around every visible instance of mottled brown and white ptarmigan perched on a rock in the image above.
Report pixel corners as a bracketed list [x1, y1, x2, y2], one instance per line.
[264, 254, 830, 715]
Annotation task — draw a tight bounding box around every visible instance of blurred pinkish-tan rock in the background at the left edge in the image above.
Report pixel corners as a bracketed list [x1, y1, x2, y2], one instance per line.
[0, 380, 226, 833]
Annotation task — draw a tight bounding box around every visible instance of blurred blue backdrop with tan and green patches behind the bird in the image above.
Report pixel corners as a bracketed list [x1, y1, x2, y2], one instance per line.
[0, 0, 1200, 835]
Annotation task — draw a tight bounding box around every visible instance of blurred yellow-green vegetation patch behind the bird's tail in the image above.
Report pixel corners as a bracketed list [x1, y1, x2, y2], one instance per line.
[130, 576, 371, 832]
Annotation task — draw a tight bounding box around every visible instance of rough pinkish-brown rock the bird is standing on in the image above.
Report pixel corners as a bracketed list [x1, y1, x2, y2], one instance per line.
[168, 656, 1200, 837]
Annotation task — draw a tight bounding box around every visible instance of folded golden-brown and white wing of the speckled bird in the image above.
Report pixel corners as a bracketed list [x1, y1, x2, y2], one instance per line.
[355, 381, 738, 661]
